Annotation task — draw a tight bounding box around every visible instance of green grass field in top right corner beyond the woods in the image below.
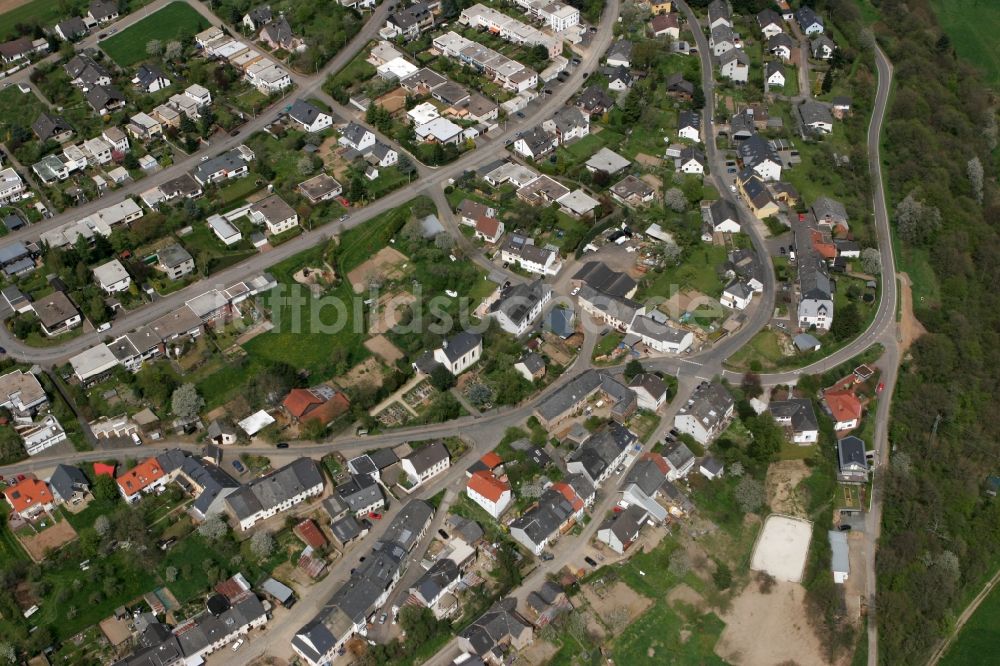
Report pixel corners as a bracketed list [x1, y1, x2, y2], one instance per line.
[931, 0, 1000, 88]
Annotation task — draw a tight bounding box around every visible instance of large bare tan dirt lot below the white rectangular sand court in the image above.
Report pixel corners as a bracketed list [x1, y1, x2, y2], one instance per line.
[715, 582, 827, 666]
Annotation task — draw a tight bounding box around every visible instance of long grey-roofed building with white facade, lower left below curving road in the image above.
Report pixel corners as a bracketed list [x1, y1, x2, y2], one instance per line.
[226, 458, 323, 531]
